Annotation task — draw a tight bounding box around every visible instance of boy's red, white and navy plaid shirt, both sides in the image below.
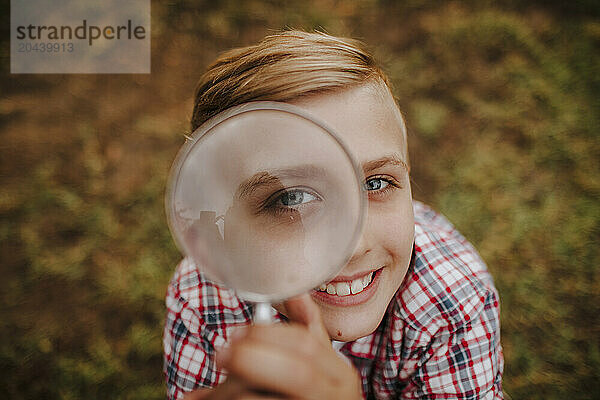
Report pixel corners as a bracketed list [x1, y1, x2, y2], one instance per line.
[163, 201, 503, 400]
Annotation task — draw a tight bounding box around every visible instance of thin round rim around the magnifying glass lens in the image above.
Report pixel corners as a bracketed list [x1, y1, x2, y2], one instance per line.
[165, 101, 367, 302]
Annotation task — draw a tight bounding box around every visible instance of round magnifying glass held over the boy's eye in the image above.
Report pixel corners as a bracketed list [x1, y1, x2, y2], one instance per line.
[166, 102, 366, 323]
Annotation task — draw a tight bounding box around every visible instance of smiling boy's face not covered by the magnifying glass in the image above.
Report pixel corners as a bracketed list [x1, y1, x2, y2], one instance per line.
[294, 84, 414, 341]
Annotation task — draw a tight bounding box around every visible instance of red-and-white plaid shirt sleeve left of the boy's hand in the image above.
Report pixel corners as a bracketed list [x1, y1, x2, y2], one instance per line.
[163, 259, 251, 399]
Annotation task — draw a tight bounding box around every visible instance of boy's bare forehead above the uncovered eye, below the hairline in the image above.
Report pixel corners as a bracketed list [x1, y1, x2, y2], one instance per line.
[292, 83, 407, 164]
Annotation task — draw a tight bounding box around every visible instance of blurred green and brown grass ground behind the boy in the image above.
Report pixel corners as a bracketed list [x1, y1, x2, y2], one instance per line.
[0, 0, 600, 399]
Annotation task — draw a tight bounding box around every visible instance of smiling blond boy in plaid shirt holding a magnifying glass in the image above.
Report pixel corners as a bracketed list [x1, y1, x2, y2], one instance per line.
[163, 31, 503, 399]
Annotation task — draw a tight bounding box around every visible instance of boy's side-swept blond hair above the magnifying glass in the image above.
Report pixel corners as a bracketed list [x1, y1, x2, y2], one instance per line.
[191, 30, 389, 131]
